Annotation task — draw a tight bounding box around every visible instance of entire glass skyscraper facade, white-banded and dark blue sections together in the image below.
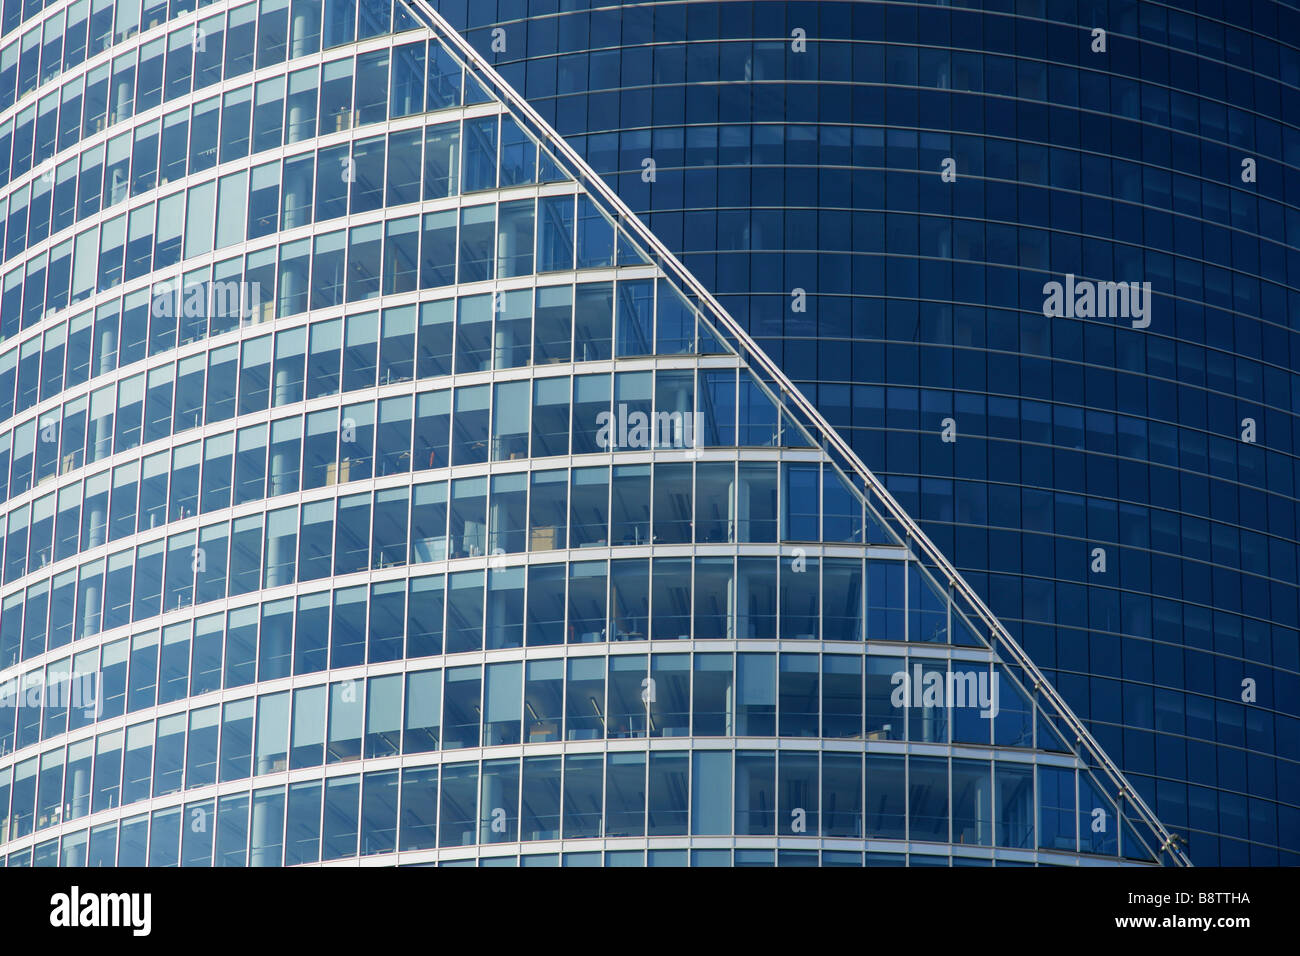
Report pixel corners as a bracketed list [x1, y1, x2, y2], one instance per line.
[0, 0, 1279, 866]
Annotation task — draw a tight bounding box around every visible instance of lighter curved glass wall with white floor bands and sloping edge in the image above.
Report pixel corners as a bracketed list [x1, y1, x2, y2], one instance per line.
[0, 0, 1182, 865]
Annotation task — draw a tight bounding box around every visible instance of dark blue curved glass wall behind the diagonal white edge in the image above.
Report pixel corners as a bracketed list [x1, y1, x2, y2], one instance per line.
[418, 0, 1300, 865]
